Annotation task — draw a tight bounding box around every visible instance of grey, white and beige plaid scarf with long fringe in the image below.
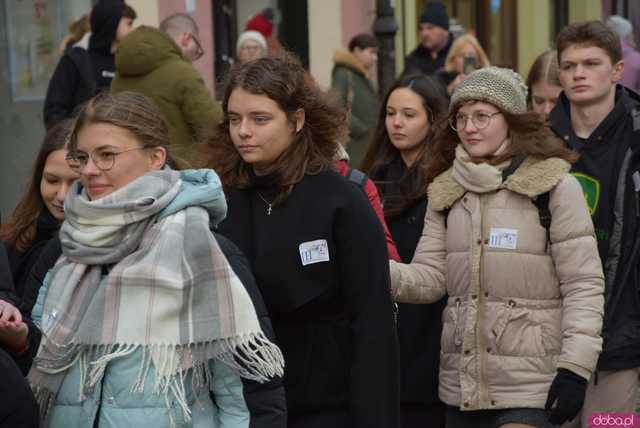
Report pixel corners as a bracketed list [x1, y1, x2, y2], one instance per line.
[29, 169, 284, 420]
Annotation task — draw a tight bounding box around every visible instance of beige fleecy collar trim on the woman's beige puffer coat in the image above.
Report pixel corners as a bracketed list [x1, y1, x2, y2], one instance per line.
[427, 156, 571, 211]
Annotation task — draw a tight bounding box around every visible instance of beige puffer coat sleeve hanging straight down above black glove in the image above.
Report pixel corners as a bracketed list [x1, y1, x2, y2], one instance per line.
[549, 174, 604, 380]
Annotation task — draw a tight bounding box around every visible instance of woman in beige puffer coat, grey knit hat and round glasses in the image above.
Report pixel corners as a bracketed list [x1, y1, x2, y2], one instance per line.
[390, 67, 604, 428]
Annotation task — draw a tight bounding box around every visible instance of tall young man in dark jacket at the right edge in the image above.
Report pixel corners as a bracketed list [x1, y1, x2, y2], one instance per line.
[549, 21, 640, 426]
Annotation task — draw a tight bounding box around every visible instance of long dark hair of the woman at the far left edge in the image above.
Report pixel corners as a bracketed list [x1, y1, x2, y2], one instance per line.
[0, 119, 73, 253]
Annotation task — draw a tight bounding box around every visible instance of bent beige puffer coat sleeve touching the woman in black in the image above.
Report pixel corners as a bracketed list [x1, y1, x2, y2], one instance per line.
[390, 202, 447, 303]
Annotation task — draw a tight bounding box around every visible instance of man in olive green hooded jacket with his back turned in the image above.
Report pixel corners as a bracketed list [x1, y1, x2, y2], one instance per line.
[111, 13, 222, 162]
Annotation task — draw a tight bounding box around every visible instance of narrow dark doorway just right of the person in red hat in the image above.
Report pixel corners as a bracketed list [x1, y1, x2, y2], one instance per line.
[278, 0, 309, 70]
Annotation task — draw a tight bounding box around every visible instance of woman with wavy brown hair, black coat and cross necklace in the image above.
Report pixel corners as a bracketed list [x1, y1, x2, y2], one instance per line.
[208, 56, 398, 428]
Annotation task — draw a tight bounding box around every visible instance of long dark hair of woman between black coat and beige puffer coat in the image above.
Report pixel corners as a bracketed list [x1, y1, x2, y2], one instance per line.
[362, 74, 447, 217]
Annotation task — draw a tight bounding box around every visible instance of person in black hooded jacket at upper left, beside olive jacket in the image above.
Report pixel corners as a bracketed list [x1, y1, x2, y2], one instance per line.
[44, 0, 137, 129]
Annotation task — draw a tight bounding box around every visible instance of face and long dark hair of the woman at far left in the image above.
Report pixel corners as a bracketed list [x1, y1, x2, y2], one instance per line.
[1, 120, 78, 298]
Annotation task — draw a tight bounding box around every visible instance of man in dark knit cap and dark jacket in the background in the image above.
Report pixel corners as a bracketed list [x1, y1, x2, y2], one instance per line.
[403, 1, 453, 74]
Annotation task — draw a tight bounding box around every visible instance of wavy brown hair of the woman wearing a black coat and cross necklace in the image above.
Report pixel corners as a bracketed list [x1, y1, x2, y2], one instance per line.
[205, 53, 346, 205]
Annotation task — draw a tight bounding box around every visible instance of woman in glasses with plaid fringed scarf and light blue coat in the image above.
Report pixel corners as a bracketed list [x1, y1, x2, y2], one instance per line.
[28, 92, 283, 428]
